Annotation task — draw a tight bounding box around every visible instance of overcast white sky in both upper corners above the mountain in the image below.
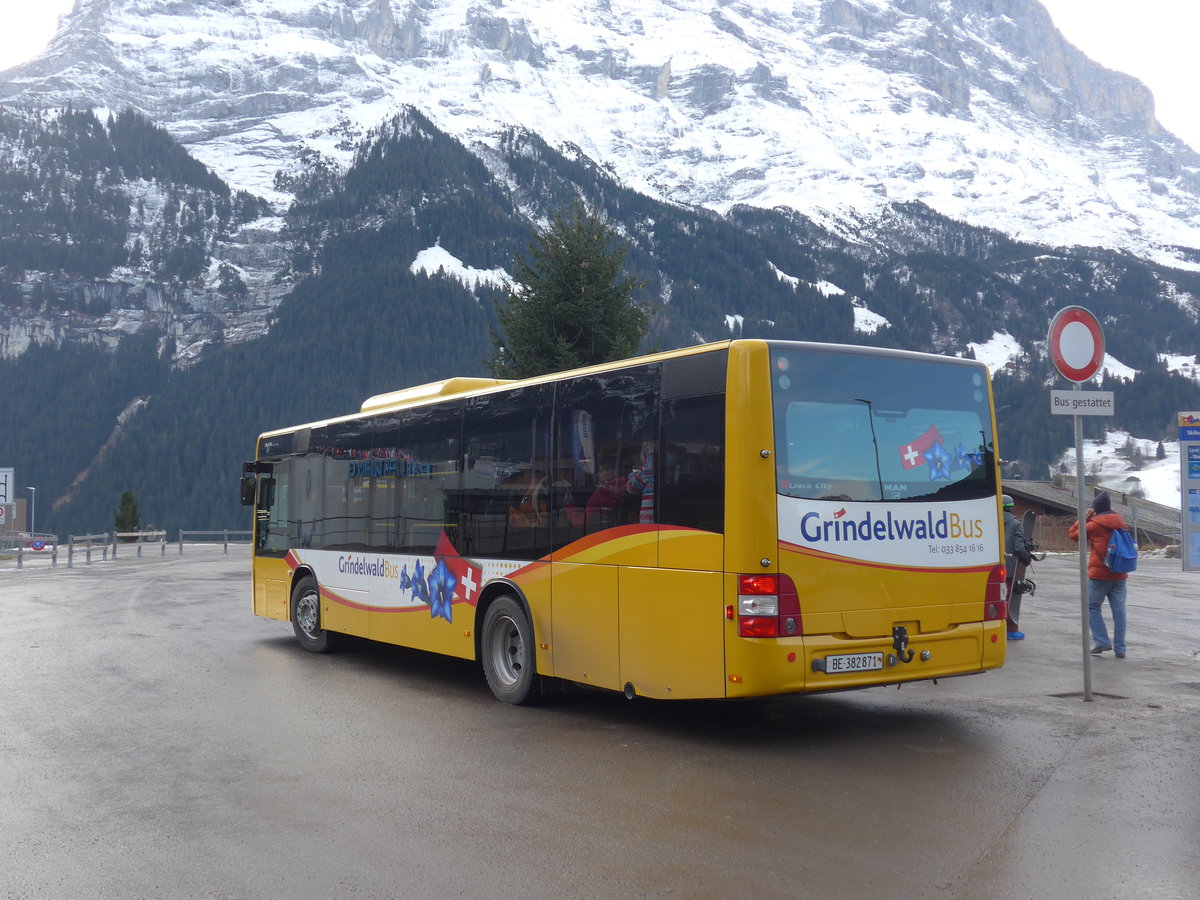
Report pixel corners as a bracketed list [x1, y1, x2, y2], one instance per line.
[0, 0, 1200, 149]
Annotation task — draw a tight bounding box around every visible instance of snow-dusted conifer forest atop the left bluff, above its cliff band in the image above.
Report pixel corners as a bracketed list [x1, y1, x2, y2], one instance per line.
[0, 108, 269, 286]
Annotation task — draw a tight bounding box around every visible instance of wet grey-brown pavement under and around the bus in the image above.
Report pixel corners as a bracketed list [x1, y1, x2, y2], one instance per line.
[0, 548, 1200, 898]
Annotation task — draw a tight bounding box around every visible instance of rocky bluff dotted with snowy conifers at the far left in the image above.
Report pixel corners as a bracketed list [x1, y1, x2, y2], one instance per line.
[0, 101, 287, 364]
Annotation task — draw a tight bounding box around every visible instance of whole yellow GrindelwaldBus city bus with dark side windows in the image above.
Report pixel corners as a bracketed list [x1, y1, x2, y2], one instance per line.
[241, 340, 1006, 703]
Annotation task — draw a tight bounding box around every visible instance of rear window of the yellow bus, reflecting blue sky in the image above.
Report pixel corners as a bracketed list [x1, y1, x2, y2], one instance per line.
[772, 346, 996, 502]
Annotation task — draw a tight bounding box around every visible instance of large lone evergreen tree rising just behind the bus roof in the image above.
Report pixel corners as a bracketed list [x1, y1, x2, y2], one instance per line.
[487, 203, 650, 378]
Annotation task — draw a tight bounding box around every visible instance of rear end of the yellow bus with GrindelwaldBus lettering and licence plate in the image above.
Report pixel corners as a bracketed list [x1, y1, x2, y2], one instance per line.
[726, 342, 1006, 696]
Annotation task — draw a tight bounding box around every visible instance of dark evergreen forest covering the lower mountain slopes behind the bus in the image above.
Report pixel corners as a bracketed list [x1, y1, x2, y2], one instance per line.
[0, 110, 1200, 535]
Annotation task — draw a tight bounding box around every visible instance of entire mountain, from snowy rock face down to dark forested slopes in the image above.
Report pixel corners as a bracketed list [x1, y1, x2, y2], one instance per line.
[0, 0, 1200, 530]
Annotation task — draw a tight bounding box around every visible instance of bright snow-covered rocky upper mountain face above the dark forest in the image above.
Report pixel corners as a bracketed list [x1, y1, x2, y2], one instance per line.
[7, 0, 1200, 269]
